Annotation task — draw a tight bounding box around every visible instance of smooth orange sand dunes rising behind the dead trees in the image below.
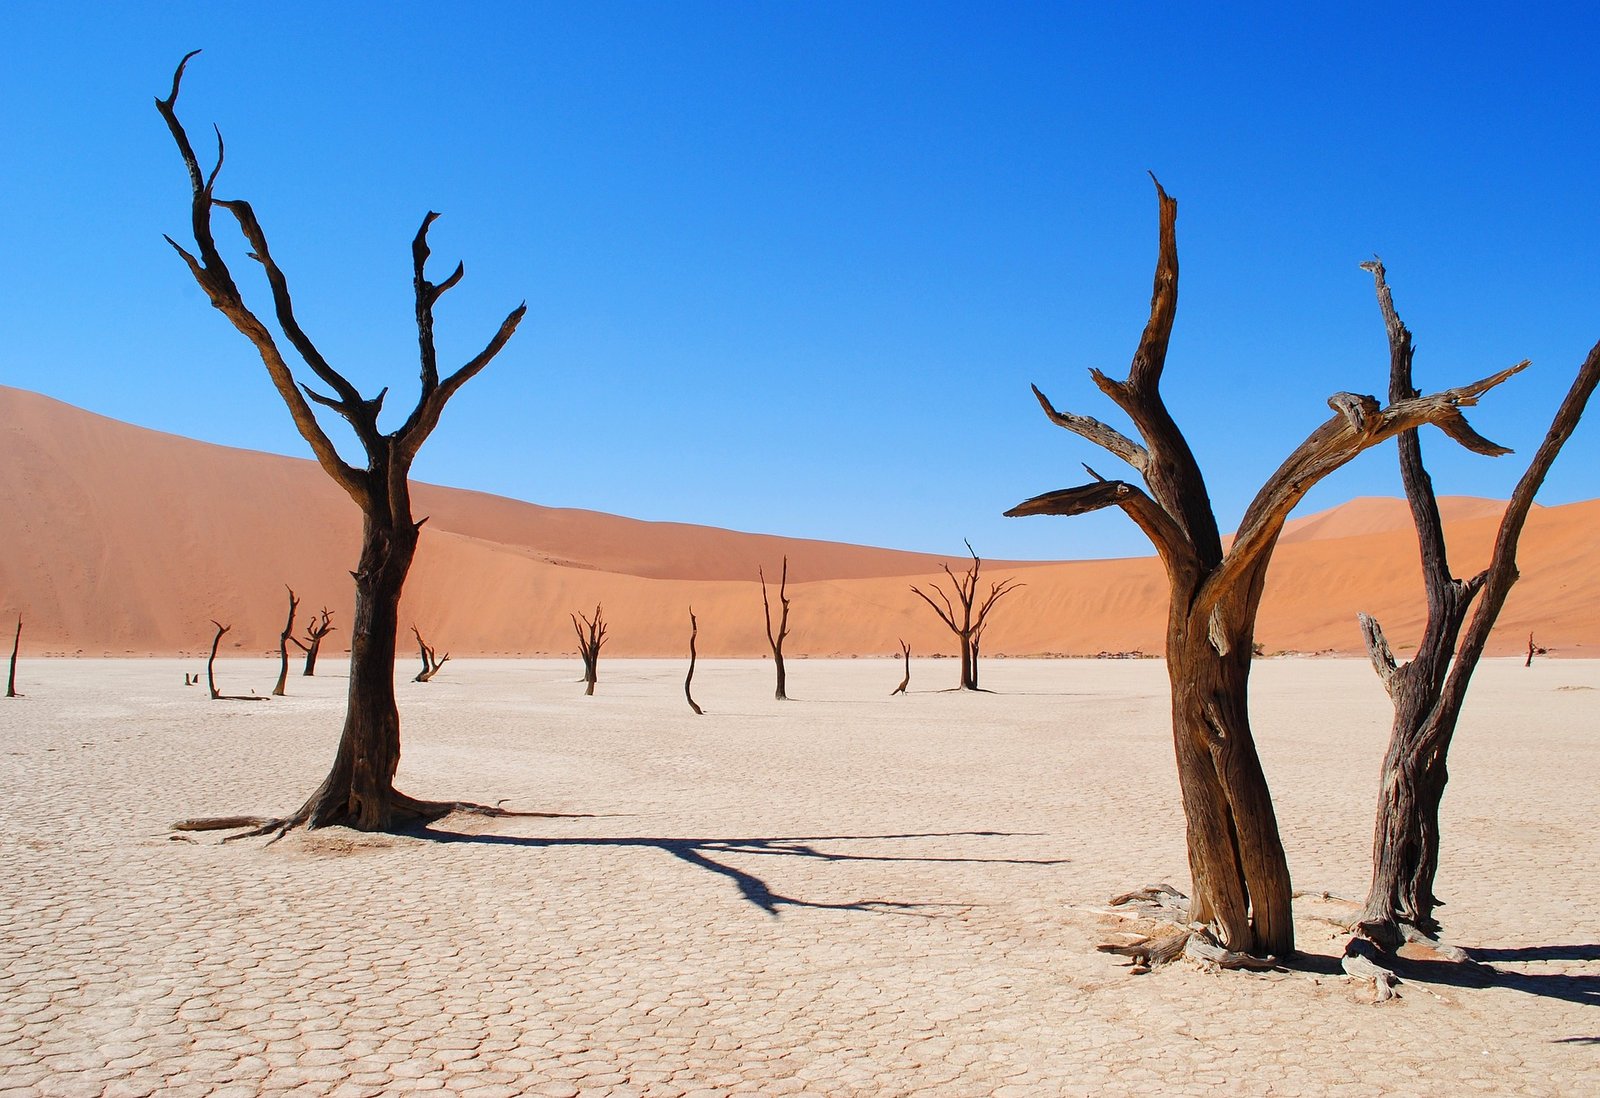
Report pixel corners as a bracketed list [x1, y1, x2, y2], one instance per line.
[0, 387, 1600, 656]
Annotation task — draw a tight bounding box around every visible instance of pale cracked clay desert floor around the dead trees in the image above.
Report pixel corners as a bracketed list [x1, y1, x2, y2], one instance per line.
[0, 658, 1600, 1096]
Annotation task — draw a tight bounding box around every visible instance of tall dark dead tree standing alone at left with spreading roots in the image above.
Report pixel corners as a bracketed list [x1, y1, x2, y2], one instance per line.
[155, 54, 525, 834]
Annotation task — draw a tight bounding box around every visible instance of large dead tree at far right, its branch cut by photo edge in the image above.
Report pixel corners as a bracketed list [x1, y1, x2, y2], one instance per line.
[1358, 261, 1600, 949]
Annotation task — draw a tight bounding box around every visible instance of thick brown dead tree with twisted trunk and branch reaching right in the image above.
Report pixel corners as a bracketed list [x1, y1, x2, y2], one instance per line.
[1006, 182, 1526, 956]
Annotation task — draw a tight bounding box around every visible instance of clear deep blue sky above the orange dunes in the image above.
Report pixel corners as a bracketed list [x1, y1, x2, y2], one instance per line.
[0, 0, 1600, 559]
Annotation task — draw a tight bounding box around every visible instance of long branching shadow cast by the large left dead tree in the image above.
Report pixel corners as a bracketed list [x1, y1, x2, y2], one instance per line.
[396, 826, 1067, 919]
